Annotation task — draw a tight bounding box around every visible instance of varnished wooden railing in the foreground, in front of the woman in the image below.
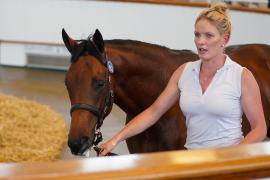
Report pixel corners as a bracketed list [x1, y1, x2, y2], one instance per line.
[0, 142, 270, 180]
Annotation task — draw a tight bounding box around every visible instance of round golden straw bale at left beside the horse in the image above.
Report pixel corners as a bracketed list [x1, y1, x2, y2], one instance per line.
[0, 94, 67, 162]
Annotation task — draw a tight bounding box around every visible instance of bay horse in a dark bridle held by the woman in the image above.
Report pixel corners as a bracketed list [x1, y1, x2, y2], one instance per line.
[62, 29, 270, 155]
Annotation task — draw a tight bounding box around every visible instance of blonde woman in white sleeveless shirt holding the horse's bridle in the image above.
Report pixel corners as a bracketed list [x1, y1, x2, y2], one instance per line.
[100, 3, 266, 156]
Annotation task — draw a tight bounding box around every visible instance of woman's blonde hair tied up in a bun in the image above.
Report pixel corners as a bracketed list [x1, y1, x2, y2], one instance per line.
[195, 3, 231, 35]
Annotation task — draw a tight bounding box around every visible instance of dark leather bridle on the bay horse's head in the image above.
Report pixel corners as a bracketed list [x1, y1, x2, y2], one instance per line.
[70, 38, 114, 145]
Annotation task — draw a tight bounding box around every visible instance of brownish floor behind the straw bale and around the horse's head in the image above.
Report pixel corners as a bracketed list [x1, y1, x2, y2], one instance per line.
[0, 66, 128, 160]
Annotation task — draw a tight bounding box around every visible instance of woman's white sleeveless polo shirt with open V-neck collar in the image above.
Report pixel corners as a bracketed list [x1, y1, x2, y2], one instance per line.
[178, 56, 243, 149]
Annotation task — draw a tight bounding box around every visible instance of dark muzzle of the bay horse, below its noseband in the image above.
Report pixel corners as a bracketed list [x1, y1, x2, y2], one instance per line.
[68, 136, 92, 156]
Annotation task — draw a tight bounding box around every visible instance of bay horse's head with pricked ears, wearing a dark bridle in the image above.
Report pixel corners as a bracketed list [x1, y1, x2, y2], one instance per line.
[62, 29, 113, 155]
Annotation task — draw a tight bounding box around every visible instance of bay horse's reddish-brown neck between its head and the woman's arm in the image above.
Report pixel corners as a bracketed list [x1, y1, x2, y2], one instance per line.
[106, 41, 195, 115]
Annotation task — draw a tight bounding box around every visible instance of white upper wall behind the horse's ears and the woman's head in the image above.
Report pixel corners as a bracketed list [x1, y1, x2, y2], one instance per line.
[0, 0, 270, 66]
